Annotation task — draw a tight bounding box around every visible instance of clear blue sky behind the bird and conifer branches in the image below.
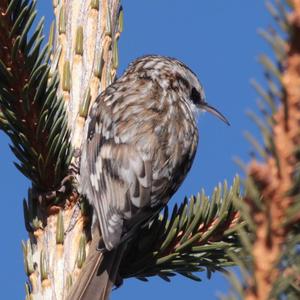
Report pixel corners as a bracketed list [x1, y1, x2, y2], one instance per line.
[0, 0, 272, 300]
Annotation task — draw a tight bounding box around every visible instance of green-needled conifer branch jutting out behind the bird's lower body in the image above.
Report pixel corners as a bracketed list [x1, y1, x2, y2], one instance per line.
[120, 178, 243, 281]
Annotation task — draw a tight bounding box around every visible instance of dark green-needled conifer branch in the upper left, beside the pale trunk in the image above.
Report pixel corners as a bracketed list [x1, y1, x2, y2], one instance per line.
[0, 0, 71, 191]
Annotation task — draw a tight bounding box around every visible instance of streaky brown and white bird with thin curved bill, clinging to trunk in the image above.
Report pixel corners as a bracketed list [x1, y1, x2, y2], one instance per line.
[70, 55, 229, 299]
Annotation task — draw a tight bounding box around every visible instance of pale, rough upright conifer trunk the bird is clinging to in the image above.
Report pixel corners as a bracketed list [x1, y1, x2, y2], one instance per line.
[23, 0, 122, 299]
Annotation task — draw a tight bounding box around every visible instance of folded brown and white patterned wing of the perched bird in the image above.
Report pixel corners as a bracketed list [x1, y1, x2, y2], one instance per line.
[83, 95, 152, 250]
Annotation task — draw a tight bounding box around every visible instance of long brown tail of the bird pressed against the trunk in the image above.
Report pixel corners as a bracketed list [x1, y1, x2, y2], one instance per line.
[67, 230, 124, 300]
